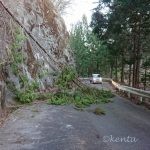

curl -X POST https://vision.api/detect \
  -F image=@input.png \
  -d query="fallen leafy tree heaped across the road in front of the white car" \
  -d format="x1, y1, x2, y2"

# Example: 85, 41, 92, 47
48, 67, 113, 108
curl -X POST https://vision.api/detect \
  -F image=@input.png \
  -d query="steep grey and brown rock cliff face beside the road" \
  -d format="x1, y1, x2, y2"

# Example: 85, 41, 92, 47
0, 0, 74, 103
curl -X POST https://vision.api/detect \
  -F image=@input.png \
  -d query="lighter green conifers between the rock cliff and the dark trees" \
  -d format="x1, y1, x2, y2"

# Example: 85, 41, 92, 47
70, 16, 108, 76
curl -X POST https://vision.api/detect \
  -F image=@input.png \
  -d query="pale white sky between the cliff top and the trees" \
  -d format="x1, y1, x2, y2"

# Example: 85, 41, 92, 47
63, 0, 98, 31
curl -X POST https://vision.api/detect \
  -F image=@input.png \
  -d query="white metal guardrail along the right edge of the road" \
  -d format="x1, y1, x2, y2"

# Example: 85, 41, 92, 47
80, 78, 150, 99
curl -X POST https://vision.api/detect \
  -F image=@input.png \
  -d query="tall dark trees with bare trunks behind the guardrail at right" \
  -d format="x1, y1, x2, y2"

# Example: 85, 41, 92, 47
91, 0, 150, 87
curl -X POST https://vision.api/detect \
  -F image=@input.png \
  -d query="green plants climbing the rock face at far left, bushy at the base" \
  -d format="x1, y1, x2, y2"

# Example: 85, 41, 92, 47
7, 28, 39, 103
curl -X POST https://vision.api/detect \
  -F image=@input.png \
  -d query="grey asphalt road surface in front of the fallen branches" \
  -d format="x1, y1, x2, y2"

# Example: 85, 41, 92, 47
0, 84, 150, 150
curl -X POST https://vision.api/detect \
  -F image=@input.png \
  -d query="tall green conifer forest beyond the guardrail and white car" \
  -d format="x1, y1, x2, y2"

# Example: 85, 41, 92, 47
70, 0, 150, 89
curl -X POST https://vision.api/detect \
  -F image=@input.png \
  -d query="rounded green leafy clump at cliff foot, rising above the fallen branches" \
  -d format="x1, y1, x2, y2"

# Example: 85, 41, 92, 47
56, 66, 77, 89
